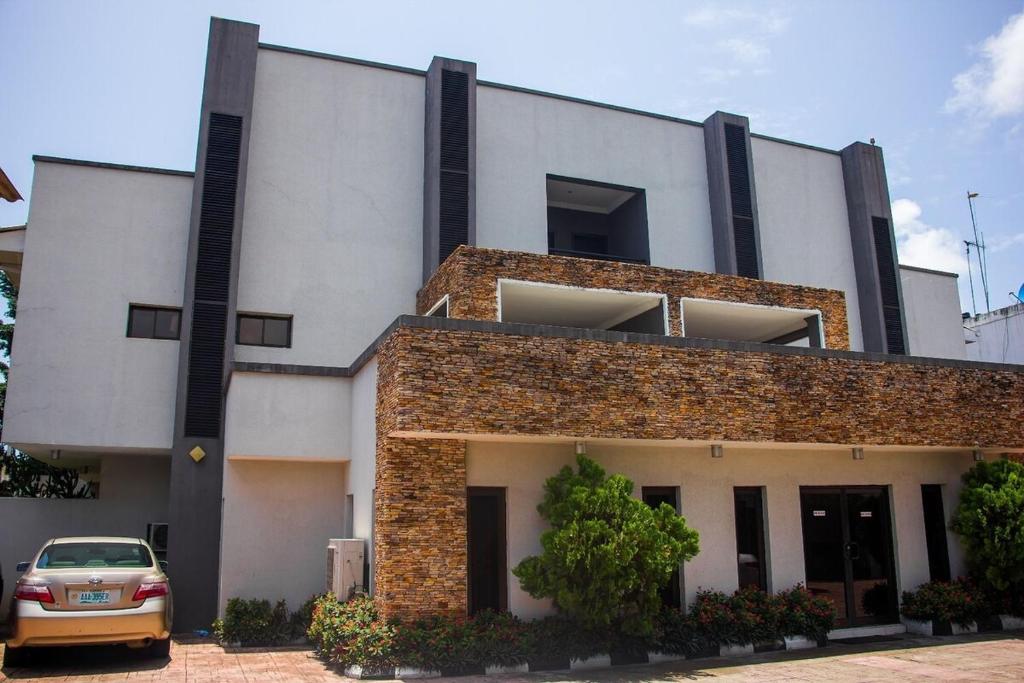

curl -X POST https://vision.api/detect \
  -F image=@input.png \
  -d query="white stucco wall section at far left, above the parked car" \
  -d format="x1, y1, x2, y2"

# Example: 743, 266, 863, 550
4, 162, 193, 452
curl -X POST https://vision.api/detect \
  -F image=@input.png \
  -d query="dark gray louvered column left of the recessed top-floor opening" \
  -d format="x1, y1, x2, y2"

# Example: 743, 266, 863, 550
423, 56, 476, 283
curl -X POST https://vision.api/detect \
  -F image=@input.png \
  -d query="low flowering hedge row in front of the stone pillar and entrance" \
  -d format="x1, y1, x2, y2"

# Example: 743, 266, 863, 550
307, 586, 836, 671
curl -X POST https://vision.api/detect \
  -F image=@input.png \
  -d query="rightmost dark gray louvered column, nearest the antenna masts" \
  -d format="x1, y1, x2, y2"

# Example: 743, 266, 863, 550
840, 142, 907, 353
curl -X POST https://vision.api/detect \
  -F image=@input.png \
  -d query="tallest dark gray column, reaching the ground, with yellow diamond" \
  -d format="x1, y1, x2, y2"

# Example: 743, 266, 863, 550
167, 18, 259, 632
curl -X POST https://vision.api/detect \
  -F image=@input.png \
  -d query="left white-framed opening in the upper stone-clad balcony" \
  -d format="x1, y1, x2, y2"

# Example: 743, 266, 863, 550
498, 280, 669, 335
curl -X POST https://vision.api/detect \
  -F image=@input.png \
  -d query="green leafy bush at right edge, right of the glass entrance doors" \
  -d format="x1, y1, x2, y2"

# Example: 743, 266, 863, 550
952, 460, 1024, 592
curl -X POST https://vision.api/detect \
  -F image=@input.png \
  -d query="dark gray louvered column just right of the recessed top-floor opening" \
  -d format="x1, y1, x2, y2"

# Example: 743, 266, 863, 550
703, 112, 764, 279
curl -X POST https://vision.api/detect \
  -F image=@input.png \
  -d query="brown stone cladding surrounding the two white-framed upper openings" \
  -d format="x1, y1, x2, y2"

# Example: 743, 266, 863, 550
416, 246, 850, 350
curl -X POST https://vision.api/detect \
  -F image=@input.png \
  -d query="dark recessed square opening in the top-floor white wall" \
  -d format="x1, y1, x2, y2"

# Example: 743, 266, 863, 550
548, 175, 650, 263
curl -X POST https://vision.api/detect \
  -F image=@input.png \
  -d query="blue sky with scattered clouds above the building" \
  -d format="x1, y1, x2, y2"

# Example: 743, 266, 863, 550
0, 0, 1024, 310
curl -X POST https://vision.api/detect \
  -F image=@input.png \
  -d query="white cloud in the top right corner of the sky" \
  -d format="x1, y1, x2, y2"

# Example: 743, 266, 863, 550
946, 12, 1024, 118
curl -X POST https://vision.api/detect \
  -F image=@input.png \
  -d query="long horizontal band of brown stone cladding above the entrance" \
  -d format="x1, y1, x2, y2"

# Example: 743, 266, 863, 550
379, 327, 1024, 450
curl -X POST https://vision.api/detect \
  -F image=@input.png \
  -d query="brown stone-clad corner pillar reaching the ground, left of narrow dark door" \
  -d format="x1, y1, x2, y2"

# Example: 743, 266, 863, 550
374, 333, 468, 620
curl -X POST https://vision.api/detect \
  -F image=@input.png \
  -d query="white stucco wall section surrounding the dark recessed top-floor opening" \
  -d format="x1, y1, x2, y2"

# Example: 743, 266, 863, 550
476, 85, 715, 271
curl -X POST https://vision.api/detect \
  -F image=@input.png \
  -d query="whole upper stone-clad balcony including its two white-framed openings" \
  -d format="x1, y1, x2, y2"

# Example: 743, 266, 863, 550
417, 246, 850, 349
